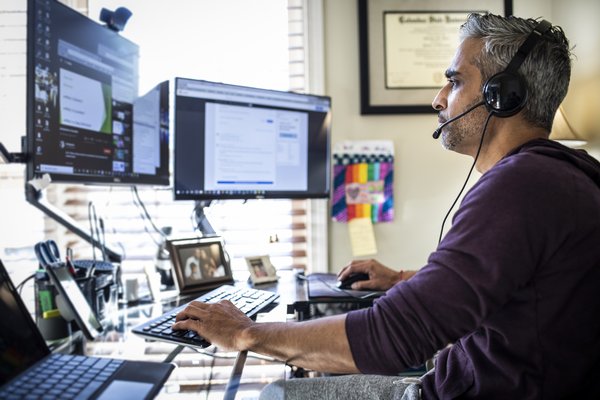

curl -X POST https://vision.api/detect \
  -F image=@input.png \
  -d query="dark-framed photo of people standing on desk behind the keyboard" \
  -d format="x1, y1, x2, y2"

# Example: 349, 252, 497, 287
167, 236, 233, 294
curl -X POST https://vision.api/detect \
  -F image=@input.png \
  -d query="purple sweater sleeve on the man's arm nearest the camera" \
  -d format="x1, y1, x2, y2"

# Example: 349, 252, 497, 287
346, 155, 548, 374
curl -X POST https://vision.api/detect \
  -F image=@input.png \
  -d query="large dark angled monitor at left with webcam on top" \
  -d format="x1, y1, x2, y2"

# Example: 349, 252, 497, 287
26, 0, 169, 185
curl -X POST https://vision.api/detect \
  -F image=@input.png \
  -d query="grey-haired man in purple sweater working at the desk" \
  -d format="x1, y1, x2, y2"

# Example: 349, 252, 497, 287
174, 14, 600, 399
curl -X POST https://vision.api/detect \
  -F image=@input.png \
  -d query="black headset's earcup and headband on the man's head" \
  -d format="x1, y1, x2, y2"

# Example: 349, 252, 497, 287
483, 20, 552, 118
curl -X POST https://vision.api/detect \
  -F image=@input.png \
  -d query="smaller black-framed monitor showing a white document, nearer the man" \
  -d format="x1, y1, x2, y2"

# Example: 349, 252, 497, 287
173, 78, 331, 200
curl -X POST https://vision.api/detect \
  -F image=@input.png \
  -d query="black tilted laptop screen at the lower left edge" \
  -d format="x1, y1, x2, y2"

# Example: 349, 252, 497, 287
0, 260, 50, 385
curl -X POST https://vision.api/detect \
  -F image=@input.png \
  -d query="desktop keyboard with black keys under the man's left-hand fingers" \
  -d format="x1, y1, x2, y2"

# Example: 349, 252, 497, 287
131, 285, 279, 347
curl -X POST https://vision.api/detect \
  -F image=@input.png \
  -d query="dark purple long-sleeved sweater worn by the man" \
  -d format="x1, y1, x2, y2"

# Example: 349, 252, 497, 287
346, 140, 600, 399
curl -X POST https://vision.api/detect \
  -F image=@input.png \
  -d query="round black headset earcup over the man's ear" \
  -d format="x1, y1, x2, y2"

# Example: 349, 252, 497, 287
483, 71, 527, 117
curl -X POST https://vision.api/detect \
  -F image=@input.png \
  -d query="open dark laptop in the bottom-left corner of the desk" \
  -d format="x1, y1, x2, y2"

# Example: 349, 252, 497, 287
0, 260, 174, 400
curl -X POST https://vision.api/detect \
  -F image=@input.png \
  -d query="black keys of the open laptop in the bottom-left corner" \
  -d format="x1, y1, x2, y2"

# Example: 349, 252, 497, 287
0, 354, 123, 400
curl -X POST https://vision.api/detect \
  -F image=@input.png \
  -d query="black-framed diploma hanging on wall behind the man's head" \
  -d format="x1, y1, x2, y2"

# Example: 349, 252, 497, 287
357, 0, 512, 115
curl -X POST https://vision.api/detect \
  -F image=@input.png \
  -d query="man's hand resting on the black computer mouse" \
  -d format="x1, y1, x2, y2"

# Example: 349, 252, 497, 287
338, 259, 414, 290
